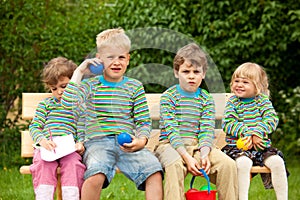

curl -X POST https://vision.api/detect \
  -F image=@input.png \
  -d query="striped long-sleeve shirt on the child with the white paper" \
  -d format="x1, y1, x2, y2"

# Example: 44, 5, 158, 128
29, 97, 83, 144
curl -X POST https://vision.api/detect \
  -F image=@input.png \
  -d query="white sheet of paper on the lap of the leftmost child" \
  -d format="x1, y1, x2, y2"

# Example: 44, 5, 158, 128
41, 135, 76, 161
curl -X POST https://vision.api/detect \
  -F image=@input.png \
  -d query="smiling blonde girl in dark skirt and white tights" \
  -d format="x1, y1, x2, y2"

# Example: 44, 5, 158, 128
222, 62, 288, 200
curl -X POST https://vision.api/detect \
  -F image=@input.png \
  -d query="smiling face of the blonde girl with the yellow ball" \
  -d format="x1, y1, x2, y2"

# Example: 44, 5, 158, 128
231, 78, 256, 98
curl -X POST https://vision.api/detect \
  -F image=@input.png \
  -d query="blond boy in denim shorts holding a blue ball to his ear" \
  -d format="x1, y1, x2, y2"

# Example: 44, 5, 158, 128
63, 28, 163, 200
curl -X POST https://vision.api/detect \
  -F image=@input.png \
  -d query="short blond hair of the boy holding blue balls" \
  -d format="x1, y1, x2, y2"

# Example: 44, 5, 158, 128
96, 28, 131, 53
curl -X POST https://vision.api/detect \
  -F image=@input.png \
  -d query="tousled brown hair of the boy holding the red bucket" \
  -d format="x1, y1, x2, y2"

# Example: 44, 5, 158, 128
173, 43, 208, 73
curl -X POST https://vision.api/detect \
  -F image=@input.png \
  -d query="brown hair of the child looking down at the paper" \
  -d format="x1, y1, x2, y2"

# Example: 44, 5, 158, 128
42, 57, 77, 89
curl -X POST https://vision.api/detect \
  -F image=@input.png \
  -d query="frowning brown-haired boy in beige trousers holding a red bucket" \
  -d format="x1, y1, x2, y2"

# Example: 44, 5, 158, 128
155, 43, 238, 200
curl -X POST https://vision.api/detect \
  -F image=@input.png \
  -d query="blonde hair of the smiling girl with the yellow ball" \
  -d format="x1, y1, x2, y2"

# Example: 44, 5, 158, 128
230, 62, 270, 96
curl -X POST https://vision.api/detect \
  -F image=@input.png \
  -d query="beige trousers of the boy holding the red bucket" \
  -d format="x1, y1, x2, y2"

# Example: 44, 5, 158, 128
155, 140, 238, 200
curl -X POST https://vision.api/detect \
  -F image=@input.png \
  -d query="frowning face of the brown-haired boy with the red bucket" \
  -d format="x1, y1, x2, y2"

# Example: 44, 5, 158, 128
174, 61, 205, 92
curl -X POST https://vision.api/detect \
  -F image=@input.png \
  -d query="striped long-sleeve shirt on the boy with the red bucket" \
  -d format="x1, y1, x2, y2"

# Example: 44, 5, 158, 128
160, 85, 215, 149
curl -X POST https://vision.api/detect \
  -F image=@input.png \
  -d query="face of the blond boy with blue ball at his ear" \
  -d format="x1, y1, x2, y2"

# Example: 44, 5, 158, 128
99, 47, 130, 82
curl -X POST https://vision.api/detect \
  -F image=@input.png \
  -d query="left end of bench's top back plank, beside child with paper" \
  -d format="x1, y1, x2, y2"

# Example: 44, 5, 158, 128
22, 93, 52, 120
